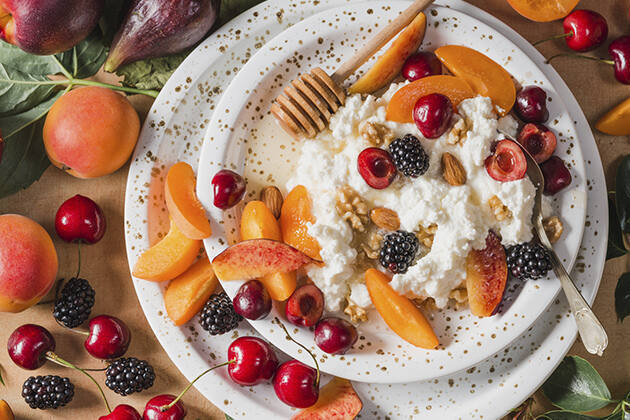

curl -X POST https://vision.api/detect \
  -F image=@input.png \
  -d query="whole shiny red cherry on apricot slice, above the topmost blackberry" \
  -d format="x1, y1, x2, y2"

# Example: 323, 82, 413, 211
413, 93, 453, 139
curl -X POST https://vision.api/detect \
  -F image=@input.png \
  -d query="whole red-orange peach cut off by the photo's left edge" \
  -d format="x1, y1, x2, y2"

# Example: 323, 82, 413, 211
0, 214, 58, 312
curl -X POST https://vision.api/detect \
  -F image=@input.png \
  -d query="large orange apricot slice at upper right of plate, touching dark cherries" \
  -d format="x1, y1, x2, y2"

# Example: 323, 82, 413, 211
435, 45, 516, 116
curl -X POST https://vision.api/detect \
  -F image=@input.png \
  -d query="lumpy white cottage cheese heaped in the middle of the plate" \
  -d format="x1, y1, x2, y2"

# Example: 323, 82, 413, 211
287, 85, 535, 311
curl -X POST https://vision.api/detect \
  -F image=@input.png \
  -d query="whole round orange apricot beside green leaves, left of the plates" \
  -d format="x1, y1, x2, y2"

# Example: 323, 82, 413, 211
44, 86, 140, 178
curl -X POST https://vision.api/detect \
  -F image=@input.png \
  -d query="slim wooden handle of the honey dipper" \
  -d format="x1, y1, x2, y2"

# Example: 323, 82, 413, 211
331, 0, 434, 85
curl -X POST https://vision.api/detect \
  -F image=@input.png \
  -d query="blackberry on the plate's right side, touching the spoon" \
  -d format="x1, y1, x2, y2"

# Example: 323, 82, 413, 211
507, 242, 552, 280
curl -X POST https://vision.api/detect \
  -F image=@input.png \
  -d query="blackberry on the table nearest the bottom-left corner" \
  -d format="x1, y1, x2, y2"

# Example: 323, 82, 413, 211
22, 375, 74, 410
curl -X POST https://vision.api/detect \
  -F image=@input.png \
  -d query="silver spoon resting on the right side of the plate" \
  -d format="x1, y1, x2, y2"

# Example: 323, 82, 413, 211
501, 132, 608, 356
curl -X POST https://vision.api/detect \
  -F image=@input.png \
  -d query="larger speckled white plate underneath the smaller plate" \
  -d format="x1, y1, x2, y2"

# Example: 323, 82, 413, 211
125, 0, 608, 419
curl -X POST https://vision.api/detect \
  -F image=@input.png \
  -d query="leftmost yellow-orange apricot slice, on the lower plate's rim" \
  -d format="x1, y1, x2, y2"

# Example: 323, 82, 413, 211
132, 220, 201, 281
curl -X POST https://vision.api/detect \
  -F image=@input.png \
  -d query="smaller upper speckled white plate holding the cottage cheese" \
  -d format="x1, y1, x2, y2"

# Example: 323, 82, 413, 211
197, 1, 586, 383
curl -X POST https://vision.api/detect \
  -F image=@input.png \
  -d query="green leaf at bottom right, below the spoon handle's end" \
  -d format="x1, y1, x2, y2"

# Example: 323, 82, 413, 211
542, 356, 613, 412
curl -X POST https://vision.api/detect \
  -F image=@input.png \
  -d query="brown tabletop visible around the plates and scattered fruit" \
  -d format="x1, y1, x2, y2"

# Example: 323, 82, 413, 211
0, 0, 630, 419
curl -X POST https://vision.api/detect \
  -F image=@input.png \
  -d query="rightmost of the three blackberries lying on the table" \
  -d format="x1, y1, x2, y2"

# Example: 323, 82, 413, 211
105, 357, 155, 397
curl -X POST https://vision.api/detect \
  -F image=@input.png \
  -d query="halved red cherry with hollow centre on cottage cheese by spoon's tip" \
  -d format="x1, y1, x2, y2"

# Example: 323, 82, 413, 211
485, 139, 527, 182
